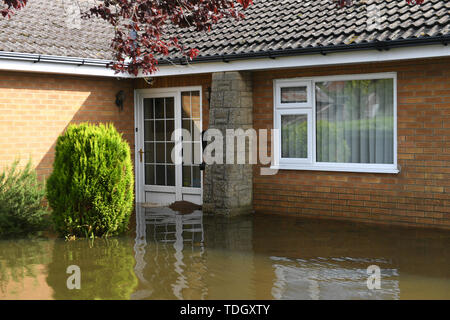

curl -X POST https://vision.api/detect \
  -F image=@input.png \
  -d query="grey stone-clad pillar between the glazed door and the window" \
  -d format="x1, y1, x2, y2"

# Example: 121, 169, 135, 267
203, 72, 253, 216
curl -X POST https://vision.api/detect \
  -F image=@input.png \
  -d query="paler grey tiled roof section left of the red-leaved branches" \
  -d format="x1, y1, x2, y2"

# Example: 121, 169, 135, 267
0, 0, 114, 60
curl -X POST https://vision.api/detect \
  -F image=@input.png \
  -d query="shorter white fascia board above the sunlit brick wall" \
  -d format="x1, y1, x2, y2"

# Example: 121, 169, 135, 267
0, 59, 134, 78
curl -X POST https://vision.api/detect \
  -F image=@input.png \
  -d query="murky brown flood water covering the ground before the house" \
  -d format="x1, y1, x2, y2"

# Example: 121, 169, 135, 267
0, 208, 450, 299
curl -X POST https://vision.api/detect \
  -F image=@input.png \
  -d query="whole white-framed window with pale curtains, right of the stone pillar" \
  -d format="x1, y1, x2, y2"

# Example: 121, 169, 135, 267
274, 74, 398, 173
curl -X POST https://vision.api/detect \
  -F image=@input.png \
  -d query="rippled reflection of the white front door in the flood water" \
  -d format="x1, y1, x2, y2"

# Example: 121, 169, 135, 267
132, 206, 206, 299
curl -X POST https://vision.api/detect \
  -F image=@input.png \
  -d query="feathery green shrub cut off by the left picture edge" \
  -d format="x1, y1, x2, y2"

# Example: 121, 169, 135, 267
0, 160, 48, 237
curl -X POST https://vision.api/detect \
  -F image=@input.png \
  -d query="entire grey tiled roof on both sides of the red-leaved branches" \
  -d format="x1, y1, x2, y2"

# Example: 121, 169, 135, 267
0, 0, 450, 61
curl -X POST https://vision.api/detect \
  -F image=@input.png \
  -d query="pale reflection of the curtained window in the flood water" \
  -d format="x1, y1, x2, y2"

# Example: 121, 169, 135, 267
271, 257, 400, 300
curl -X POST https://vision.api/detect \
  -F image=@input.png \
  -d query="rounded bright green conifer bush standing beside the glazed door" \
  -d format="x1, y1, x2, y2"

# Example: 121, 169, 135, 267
47, 123, 134, 237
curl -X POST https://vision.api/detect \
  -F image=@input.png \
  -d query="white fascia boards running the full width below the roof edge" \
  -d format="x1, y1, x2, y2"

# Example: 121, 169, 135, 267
0, 45, 450, 78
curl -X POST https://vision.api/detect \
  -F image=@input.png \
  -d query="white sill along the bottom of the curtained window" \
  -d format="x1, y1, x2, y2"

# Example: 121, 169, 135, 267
270, 164, 400, 174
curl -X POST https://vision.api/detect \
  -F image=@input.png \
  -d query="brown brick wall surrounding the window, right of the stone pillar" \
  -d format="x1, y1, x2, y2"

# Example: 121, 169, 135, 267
253, 58, 450, 228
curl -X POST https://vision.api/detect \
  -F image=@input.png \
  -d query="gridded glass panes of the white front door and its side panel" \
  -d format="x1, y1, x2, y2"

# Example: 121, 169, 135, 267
144, 91, 202, 188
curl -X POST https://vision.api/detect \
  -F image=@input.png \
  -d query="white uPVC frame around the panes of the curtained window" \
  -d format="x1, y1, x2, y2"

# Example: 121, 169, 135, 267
271, 72, 400, 174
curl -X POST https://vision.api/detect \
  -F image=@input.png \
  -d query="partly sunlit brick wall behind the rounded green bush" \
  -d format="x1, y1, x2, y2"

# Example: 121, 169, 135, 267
0, 71, 134, 176
